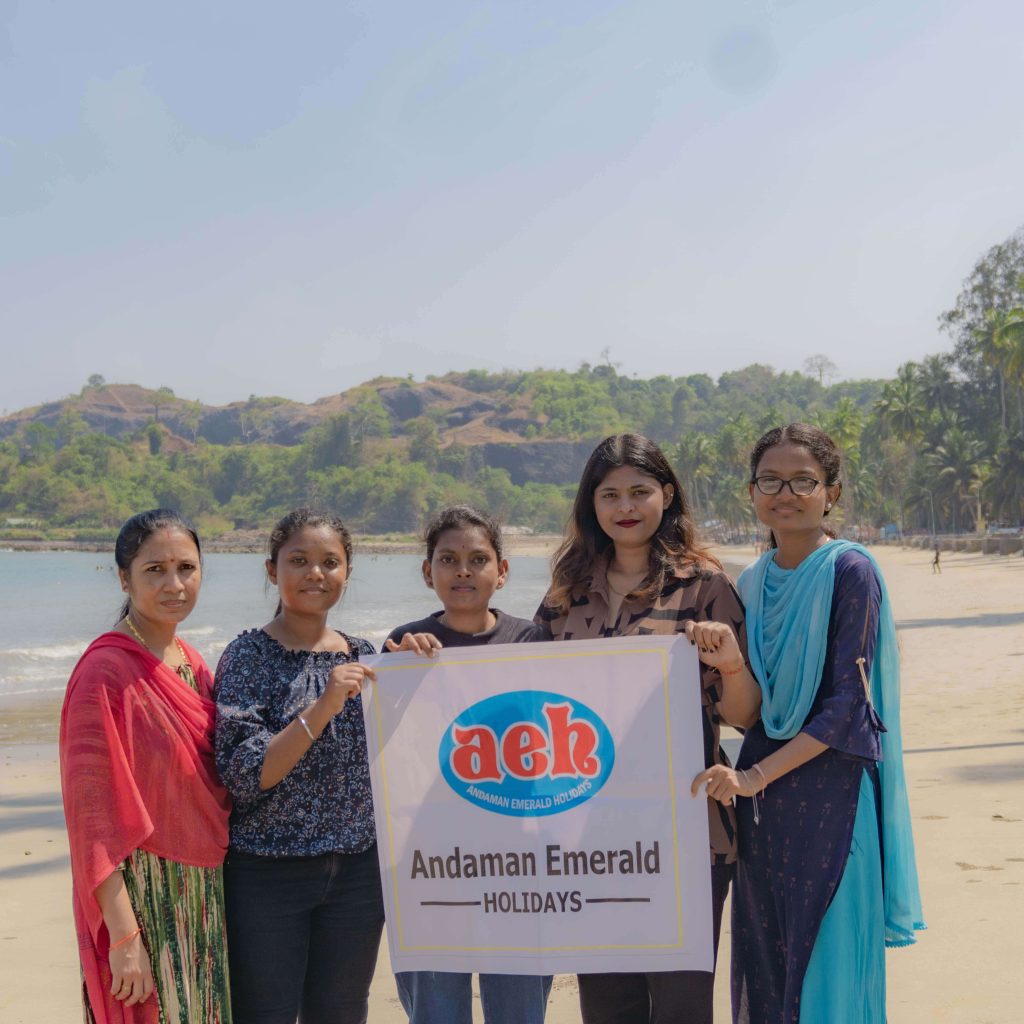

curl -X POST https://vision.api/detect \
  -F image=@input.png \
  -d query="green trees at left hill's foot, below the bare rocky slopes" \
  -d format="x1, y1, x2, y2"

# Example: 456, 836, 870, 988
0, 414, 569, 534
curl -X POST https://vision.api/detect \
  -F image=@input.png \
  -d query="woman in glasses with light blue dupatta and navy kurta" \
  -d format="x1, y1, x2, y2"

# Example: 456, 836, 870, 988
695, 423, 925, 1024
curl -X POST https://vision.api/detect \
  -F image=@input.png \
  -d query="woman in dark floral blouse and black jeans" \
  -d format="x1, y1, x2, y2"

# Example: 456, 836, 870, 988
216, 508, 425, 1024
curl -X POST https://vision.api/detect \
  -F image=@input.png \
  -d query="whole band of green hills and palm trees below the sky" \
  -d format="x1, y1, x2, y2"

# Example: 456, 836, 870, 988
0, 229, 1024, 536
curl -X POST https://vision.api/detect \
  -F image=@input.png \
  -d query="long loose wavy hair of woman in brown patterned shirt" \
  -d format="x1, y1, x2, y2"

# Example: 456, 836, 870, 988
547, 434, 722, 610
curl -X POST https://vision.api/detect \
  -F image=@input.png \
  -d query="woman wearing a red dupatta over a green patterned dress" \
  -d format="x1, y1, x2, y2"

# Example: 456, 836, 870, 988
58, 509, 231, 1024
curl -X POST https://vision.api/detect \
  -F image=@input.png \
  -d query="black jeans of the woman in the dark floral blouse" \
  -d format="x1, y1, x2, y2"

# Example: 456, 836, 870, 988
224, 847, 384, 1024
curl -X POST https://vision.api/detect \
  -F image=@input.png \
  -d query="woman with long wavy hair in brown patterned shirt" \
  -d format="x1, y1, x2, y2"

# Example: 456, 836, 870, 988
536, 434, 761, 1024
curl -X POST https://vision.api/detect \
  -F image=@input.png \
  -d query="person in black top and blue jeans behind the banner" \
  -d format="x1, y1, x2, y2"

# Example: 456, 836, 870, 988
385, 505, 552, 1024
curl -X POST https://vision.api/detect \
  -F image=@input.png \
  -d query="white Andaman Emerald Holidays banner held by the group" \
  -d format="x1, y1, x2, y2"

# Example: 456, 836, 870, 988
362, 636, 712, 974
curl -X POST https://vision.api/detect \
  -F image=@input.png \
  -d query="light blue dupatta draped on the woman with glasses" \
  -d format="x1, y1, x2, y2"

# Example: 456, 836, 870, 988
738, 541, 926, 946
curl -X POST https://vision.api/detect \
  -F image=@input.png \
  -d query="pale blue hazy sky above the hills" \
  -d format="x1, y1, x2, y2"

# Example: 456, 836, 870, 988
0, 0, 1024, 411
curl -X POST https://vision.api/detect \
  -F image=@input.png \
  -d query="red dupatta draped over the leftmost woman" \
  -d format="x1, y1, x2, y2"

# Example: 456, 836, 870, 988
59, 633, 230, 1024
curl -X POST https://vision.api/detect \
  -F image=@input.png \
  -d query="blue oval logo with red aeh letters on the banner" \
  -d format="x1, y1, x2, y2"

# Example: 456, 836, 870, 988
437, 690, 615, 817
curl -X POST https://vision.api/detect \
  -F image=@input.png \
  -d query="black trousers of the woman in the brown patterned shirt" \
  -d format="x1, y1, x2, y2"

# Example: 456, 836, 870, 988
579, 864, 736, 1024
